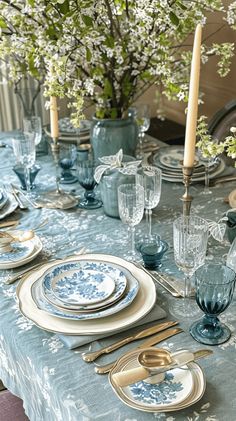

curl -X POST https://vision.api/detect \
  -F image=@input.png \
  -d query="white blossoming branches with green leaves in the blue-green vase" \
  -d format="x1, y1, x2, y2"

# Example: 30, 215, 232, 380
0, 0, 236, 126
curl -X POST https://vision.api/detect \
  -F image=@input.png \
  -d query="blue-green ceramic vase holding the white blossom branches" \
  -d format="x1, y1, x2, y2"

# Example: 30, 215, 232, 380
90, 117, 138, 161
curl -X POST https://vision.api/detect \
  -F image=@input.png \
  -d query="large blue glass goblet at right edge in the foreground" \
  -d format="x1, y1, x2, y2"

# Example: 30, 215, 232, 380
190, 263, 236, 345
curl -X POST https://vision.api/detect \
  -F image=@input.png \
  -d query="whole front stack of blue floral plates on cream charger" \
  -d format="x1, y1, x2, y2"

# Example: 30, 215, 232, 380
17, 254, 156, 335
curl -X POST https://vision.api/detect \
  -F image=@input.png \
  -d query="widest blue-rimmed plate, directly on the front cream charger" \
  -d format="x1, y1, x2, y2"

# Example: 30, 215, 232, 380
31, 262, 139, 320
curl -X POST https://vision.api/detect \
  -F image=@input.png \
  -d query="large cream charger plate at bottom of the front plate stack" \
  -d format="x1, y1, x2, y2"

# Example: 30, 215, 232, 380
17, 254, 156, 335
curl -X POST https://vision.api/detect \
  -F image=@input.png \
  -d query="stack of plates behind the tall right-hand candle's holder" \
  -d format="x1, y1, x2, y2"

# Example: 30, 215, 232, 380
153, 146, 225, 182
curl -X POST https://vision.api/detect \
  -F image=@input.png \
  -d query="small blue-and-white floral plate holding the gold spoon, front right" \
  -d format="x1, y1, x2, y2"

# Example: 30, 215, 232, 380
109, 349, 206, 412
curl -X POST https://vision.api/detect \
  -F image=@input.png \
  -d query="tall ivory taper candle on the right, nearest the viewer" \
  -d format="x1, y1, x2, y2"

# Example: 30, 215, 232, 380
183, 24, 202, 167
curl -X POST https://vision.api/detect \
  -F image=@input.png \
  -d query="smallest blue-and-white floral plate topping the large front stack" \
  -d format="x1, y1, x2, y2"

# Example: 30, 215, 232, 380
50, 265, 115, 305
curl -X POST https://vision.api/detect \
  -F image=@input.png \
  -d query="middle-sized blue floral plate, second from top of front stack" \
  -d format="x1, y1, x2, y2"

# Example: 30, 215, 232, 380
42, 260, 127, 312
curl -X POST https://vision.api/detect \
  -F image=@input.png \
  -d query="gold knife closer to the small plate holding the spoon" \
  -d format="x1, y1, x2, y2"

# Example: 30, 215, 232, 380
94, 327, 183, 374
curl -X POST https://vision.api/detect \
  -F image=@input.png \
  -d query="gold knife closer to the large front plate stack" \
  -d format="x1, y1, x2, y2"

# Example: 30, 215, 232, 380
82, 321, 179, 363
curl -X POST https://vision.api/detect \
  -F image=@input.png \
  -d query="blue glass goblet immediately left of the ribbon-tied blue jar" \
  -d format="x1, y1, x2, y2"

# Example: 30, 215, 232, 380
78, 160, 102, 209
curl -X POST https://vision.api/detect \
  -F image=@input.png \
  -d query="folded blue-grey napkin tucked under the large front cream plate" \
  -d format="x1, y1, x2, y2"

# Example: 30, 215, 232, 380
58, 304, 166, 349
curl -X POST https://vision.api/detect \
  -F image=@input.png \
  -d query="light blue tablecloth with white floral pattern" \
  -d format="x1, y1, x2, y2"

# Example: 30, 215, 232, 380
0, 134, 236, 421
